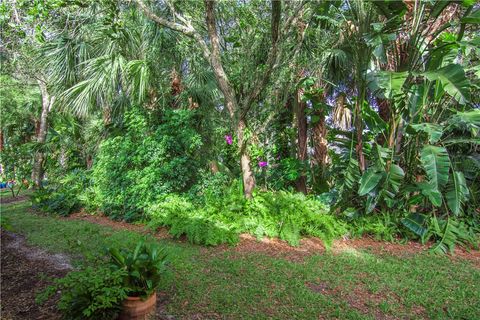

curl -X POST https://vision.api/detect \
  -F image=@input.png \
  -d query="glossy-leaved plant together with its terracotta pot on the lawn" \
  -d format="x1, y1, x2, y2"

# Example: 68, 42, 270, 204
109, 241, 167, 320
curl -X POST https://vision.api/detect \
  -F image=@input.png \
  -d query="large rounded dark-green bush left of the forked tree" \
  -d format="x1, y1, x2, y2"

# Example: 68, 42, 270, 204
93, 110, 202, 220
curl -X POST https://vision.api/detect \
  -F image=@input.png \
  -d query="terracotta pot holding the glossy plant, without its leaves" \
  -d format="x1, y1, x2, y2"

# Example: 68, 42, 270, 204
118, 292, 157, 320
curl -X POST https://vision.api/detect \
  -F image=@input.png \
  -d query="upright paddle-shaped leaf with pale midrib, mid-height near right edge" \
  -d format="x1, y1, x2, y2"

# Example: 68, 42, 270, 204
420, 145, 450, 191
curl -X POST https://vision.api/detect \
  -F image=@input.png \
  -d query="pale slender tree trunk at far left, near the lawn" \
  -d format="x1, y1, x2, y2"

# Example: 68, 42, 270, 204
32, 80, 55, 188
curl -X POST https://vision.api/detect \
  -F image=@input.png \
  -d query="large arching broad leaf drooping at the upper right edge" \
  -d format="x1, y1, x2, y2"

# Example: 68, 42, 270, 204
424, 64, 470, 104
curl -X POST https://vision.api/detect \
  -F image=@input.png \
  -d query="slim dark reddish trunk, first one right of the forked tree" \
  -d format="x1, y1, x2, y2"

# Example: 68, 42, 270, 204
295, 90, 307, 194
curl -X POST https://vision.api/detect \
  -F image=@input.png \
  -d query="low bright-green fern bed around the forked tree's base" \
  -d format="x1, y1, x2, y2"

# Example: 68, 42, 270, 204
148, 184, 346, 245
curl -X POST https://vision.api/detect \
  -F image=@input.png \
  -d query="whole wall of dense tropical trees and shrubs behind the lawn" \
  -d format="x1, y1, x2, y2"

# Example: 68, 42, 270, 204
0, 0, 480, 252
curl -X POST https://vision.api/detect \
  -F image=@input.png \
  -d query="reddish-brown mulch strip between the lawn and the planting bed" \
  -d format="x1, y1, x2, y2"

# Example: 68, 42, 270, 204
67, 211, 480, 268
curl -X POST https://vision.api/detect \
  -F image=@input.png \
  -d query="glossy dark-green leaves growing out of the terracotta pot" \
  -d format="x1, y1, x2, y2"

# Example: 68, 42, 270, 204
109, 241, 167, 298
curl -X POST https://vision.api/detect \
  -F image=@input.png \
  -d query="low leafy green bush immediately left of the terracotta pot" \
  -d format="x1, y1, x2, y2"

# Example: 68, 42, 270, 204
37, 267, 127, 320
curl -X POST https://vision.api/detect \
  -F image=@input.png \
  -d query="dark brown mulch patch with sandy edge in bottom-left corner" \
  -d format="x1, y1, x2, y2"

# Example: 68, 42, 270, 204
0, 229, 70, 320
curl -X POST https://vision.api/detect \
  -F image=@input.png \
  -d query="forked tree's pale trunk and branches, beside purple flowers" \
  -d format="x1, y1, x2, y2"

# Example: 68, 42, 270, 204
135, 0, 303, 198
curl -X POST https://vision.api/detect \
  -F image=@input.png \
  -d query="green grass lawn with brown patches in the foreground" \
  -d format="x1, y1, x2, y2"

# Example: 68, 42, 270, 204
2, 202, 480, 319
